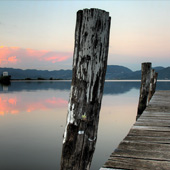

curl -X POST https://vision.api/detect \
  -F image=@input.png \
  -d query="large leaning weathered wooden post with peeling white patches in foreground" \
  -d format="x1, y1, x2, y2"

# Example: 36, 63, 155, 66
61, 9, 110, 170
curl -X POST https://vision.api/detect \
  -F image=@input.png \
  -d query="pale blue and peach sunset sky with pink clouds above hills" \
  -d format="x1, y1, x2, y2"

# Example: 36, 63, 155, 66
0, 0, 170, 70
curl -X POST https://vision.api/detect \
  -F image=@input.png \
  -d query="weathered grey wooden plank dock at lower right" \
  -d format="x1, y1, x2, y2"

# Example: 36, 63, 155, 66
100, 91, 170, 170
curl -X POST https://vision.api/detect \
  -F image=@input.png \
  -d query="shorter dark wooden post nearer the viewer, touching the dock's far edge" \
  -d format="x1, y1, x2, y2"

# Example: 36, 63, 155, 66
137, 63, 151, 119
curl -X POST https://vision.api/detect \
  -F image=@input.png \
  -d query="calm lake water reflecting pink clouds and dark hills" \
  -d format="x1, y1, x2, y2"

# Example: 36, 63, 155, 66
0, 81, 170, 170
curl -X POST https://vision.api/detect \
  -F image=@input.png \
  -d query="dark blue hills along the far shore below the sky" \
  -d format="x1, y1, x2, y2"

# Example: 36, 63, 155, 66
0, 65, 170, 80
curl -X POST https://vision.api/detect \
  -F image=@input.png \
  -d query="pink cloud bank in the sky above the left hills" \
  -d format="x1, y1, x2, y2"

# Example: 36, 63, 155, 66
0, 46, 72, 66
